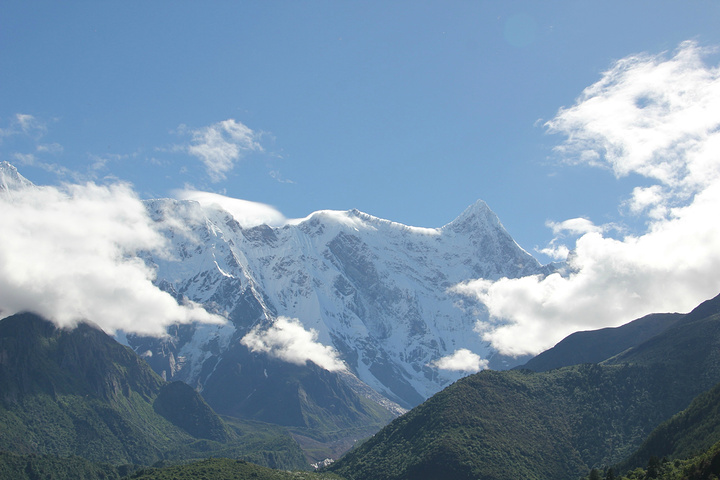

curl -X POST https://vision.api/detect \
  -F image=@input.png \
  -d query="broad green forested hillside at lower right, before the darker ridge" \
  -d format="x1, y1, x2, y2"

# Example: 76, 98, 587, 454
330, 292, 720, 479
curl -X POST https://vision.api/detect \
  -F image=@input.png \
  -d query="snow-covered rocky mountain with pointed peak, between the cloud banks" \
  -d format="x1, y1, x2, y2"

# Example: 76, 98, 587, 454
128, 199, 544, 407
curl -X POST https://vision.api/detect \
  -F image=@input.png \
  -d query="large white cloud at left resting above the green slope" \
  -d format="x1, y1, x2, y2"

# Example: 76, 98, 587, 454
0, 179, 224, 335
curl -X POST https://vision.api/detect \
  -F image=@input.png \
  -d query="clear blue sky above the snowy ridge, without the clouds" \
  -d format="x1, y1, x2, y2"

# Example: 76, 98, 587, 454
0, 0, 720, 261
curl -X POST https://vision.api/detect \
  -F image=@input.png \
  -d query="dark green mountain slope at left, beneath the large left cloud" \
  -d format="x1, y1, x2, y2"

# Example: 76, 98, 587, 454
0, 313, 306, 467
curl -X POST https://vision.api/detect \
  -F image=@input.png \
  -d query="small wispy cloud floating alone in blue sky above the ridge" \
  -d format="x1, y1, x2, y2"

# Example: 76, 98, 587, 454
179, 118, 263, 182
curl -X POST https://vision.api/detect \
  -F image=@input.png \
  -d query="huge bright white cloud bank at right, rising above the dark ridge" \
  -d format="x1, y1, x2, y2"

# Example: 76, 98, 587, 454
455, 42, 720, 355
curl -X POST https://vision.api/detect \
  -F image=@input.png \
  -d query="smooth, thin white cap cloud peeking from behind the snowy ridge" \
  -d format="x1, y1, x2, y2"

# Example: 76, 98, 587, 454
174, 190, 286, 228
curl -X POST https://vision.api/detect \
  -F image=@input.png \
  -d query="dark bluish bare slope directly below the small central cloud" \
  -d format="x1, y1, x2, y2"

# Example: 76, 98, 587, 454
198, 338, 397, 463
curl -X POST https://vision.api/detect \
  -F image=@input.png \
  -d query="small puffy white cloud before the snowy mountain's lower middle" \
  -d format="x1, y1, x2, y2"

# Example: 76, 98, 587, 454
240, 317, 345, 371
